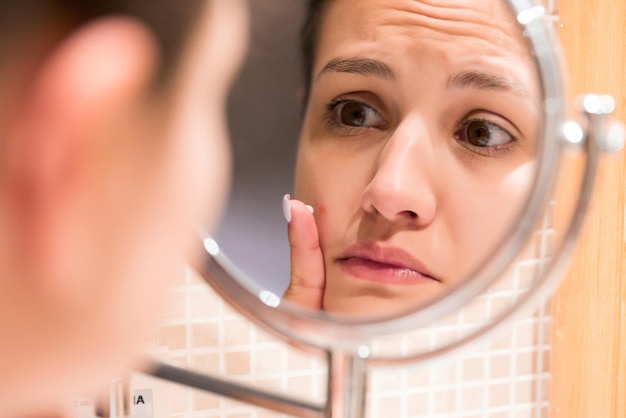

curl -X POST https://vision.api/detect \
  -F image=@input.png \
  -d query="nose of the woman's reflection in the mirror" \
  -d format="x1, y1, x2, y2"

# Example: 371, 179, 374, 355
361, 119, 437, 227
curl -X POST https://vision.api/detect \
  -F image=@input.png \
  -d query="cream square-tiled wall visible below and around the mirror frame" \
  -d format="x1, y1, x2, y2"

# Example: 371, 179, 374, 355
150, 211, 553, 418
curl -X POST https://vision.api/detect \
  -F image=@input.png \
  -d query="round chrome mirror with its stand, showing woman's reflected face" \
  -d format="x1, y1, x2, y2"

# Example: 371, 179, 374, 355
145, 0, 623, 416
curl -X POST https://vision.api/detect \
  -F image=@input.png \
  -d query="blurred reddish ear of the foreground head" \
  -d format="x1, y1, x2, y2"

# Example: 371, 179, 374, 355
2, 17, 157, 274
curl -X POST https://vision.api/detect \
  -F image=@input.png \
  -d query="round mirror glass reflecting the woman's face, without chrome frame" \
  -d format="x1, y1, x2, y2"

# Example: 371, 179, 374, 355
216, 0, 543, 317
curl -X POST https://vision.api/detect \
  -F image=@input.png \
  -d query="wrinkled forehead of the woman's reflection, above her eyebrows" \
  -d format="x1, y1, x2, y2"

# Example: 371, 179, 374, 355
313, 0, 538, 93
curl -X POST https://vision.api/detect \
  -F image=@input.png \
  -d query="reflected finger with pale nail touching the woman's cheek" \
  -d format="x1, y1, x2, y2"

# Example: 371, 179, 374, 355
283, 195, 326, 310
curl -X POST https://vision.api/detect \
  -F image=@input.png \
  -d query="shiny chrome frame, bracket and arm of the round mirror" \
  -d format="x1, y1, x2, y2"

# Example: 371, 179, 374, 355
144, 0, 624, 418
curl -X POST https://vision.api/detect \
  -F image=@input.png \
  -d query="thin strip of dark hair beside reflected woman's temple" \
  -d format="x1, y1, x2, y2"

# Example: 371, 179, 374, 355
300, 0, 331, 105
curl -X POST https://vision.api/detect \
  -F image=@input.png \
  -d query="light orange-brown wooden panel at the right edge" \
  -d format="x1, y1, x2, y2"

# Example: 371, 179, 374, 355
550, 0, 626, 418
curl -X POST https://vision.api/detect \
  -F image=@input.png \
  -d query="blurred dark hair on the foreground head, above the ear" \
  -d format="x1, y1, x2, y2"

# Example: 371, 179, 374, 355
0, 0, 205, 85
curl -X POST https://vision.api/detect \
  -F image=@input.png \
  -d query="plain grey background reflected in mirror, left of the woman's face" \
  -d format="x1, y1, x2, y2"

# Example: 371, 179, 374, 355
216, 0, 305, 295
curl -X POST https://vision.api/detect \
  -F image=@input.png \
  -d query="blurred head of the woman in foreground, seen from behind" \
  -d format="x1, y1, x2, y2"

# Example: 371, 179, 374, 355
0, 0, 247, 416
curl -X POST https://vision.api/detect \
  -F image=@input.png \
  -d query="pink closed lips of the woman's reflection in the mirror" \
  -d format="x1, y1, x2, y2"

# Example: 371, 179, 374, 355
337, 244, 441, 284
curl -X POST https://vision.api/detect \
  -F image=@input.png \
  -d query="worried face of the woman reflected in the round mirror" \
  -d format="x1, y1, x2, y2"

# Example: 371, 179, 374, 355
295, 0, 541, 314
